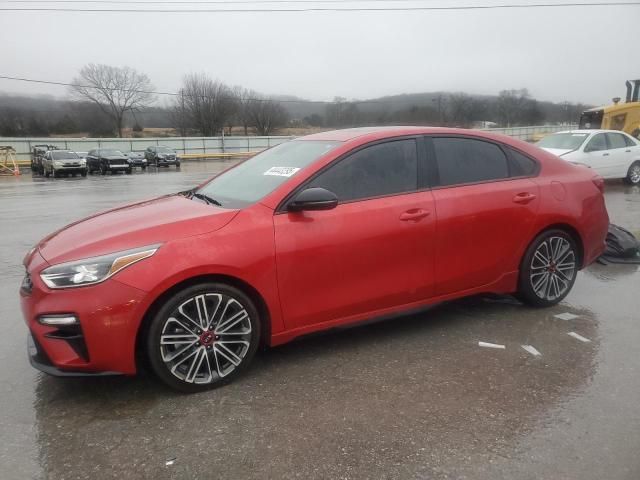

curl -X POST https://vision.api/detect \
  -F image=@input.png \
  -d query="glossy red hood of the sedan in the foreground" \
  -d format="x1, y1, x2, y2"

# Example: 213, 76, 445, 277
38, 195, 238, 264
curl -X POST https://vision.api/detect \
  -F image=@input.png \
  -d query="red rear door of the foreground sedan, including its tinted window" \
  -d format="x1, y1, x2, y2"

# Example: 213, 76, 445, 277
427, 136, 539, 295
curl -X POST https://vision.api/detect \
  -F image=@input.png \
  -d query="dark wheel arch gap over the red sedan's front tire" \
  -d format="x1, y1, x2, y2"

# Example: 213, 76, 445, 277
135, 274, 271, 365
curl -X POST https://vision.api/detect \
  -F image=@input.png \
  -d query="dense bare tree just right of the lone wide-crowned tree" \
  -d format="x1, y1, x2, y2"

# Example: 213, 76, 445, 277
181, 73, 238, 137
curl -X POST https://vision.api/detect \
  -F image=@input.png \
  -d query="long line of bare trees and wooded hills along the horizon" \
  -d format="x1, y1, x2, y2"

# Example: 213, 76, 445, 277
0, 64, 587, 136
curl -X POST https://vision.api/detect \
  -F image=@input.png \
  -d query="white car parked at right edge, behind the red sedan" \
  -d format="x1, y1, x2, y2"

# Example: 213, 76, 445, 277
538, 130, 640, 185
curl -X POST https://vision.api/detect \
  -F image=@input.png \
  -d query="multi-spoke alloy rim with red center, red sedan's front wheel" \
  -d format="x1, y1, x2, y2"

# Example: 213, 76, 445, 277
160, 293, 252, 384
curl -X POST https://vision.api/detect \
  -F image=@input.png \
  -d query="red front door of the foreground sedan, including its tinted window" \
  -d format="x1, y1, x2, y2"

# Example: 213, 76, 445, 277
274, 138, 435, 328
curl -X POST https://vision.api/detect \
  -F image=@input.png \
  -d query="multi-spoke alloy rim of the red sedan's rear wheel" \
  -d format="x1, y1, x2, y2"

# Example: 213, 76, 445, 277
529, 237, 576, 301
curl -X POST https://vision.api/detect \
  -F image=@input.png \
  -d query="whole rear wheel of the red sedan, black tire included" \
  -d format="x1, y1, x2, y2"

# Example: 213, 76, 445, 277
517, 229, 580, 307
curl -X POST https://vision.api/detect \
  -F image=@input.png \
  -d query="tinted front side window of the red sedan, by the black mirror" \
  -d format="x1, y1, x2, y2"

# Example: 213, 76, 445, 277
308, 139, 418, 202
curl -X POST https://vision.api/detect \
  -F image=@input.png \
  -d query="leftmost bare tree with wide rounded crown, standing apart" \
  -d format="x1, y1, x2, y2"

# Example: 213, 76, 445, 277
71, 63, 154, 137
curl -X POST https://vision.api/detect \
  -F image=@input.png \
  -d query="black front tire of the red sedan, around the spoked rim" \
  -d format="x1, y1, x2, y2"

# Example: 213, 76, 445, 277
144, 282, 261, 393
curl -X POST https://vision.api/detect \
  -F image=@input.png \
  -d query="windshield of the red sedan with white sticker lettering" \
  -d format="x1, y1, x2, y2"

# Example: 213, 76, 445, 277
198, 140, 340, 208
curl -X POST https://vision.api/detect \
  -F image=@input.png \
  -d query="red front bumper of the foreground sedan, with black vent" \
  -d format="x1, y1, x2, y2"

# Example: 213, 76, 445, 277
20, 253, 148, 376
